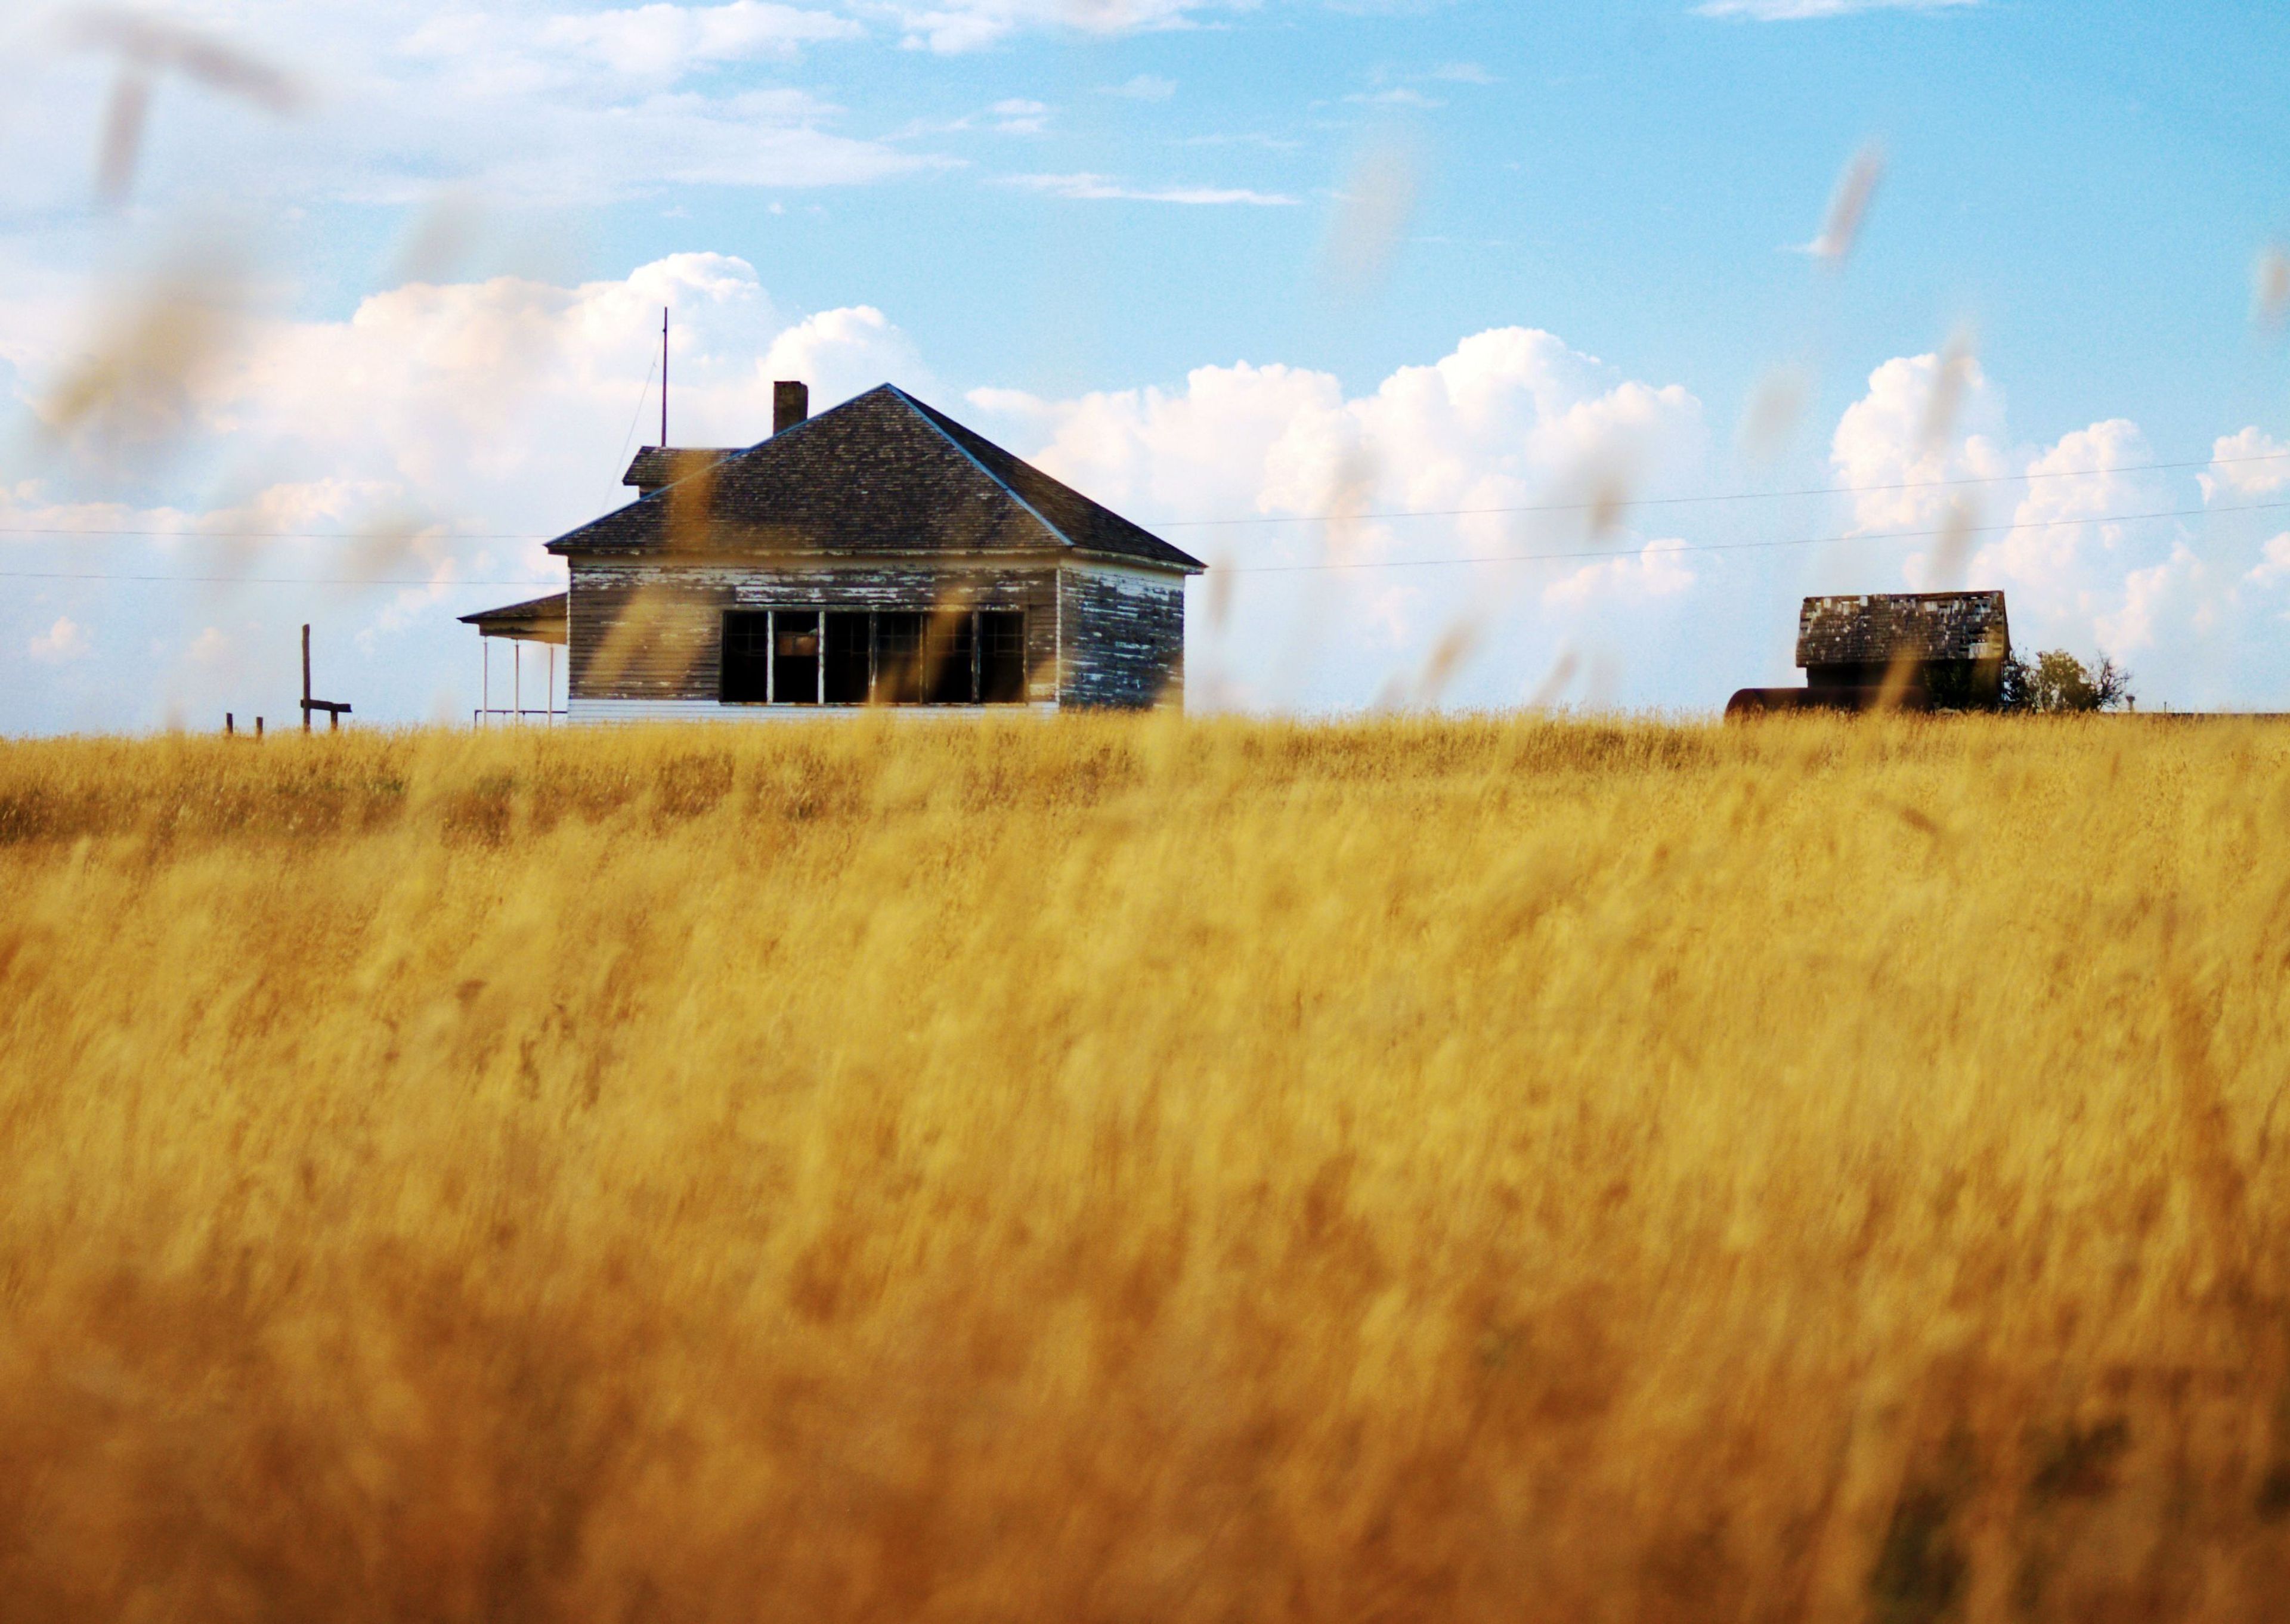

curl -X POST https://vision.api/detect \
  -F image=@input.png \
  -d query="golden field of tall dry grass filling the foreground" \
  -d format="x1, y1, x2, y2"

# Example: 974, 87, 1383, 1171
0, 719, 2290, 1624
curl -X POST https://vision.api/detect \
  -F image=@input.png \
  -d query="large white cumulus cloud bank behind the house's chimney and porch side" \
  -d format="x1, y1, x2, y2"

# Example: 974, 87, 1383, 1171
0, 254, 934, 729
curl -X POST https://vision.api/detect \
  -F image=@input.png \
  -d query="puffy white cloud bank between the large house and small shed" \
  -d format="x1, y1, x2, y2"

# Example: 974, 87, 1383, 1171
971, 327, 1706, 705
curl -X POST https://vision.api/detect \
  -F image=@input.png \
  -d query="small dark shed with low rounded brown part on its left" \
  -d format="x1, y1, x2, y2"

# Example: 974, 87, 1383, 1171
1725, 591, 2011, 717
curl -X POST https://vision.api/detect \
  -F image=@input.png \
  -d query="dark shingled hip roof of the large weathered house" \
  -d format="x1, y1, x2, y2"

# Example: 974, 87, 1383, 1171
550, 385, 1207, 575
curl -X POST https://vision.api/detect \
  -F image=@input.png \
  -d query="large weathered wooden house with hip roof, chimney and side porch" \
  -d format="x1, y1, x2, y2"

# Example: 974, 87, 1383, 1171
463, 383, 1205, 721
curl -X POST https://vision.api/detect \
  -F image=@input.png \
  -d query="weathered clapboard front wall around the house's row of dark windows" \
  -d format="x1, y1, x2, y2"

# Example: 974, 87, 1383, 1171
568, 559, 1058, 703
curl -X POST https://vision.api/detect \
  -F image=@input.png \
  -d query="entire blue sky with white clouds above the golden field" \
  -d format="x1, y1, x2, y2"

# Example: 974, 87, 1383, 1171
0, 0, 2290, 733
